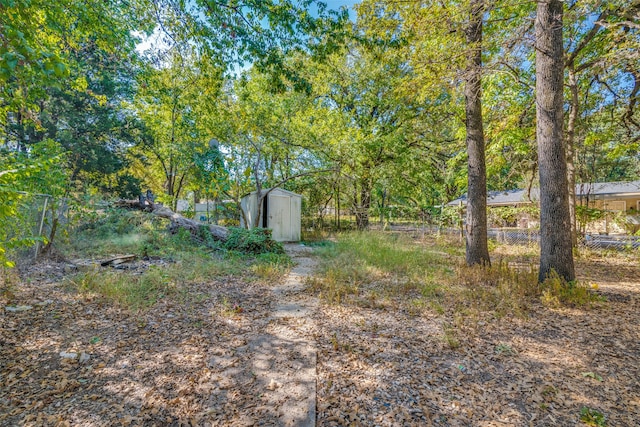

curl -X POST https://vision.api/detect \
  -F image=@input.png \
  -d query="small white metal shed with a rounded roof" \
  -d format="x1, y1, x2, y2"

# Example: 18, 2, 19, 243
240, 188, 302, 242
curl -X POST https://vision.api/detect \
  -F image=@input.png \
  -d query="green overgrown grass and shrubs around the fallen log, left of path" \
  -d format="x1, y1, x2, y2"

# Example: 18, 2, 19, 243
61, 209, 291, 310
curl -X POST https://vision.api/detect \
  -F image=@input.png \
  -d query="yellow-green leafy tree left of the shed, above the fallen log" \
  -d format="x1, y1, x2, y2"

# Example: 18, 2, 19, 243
132, 47, 222, 209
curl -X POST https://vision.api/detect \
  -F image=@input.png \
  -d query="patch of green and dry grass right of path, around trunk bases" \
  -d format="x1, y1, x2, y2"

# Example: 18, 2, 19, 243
312, 233, 603, 318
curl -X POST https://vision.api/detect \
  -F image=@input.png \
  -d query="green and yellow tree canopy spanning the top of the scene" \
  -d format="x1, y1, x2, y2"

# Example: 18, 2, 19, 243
0, 0, 640, 280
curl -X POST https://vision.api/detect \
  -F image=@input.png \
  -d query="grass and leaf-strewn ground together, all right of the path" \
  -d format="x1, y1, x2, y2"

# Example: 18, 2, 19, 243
314, 233, 640, 426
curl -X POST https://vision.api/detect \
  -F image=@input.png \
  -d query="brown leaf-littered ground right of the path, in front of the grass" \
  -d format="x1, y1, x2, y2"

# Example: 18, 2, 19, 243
316, 242, 640, 427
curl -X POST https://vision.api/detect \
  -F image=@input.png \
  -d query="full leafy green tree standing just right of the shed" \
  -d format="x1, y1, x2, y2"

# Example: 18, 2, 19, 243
311, 36, 427, 229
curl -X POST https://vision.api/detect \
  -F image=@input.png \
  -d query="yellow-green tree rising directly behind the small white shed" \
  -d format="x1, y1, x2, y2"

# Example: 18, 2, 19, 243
209, 68, 327, 228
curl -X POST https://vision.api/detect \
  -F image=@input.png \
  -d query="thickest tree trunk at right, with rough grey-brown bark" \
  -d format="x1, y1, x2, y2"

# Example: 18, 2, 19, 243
535, 0, 575, 281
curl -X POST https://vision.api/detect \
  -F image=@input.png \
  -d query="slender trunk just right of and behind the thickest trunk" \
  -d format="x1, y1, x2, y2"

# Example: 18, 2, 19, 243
566, 64, 580, 247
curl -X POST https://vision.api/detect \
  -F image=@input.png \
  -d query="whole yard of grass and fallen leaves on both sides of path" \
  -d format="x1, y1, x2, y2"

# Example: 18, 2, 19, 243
0, 220, 640, 426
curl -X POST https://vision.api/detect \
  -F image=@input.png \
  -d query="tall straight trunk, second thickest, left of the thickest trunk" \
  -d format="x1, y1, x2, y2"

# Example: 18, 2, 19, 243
464, 0, 490, 265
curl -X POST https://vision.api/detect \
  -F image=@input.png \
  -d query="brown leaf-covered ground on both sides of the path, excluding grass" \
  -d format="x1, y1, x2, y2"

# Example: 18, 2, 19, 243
0, 246, 640, 426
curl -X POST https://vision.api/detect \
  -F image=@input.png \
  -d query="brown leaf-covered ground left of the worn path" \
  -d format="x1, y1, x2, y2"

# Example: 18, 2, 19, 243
0, 264, 294, 426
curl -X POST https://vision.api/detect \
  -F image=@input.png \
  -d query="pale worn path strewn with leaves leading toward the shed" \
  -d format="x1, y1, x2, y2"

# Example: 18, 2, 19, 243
249, 244, 317, 426
